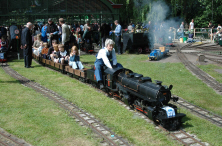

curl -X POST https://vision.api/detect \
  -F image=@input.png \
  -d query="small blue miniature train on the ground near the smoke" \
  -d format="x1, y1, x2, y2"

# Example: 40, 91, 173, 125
148, 47, 169, 60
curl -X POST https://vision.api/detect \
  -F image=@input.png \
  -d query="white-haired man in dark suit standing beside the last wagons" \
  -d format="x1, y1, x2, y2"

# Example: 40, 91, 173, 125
21, 22, 32, 68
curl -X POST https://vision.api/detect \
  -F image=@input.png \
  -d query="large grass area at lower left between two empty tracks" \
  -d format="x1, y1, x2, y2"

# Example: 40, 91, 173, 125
0, 68, 98, 146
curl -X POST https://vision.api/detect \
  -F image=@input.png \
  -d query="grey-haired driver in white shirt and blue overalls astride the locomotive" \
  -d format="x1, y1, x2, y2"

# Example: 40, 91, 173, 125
95, 39, 123, 89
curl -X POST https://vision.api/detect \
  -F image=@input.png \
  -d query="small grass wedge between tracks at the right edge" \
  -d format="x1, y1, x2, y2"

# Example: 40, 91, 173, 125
198, 64, 222, 83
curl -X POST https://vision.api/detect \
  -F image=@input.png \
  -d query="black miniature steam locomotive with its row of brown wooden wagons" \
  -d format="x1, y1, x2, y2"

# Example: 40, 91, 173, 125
33, 54, 186, 130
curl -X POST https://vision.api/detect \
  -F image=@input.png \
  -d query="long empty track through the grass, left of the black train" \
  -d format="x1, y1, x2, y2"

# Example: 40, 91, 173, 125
0, 64, 130, 146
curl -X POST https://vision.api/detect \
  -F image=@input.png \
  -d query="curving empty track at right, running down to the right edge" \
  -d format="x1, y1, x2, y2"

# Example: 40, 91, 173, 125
177, 46, 222, 95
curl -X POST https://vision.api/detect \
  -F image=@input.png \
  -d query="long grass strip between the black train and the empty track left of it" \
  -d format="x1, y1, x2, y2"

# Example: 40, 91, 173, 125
7, 60, 178, 146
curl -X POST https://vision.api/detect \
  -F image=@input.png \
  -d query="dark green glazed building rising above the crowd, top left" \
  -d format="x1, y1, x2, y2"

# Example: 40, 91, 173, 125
0, 0, 119, 25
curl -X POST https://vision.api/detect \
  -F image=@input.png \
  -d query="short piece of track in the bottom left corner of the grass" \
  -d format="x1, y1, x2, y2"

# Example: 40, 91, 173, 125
0, 128, 31, 146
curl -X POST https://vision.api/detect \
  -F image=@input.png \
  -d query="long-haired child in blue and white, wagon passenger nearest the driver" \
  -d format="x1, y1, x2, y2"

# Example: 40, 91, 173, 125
69, 46, 84, 69
